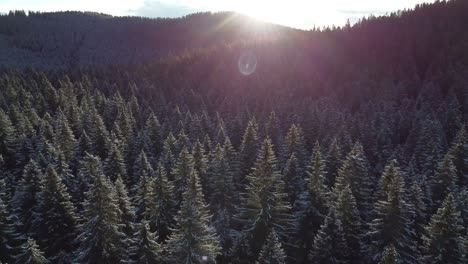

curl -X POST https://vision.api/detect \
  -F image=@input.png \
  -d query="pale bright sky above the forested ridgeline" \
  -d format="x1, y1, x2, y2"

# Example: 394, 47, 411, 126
0, 0, 433, 29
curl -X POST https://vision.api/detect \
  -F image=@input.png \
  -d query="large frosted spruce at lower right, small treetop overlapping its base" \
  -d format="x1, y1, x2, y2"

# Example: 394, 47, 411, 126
366, 162, 419, 263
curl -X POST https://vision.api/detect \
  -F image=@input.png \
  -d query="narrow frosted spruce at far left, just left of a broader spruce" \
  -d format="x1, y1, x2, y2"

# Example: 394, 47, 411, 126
12, 160, 43, 233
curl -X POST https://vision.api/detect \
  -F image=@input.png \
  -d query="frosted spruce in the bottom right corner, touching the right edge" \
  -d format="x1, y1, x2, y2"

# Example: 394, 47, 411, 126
421, 194, 467, 264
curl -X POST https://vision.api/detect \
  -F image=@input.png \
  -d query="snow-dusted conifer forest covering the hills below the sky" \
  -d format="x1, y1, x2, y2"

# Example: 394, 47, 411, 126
0, 0, 468, 264
